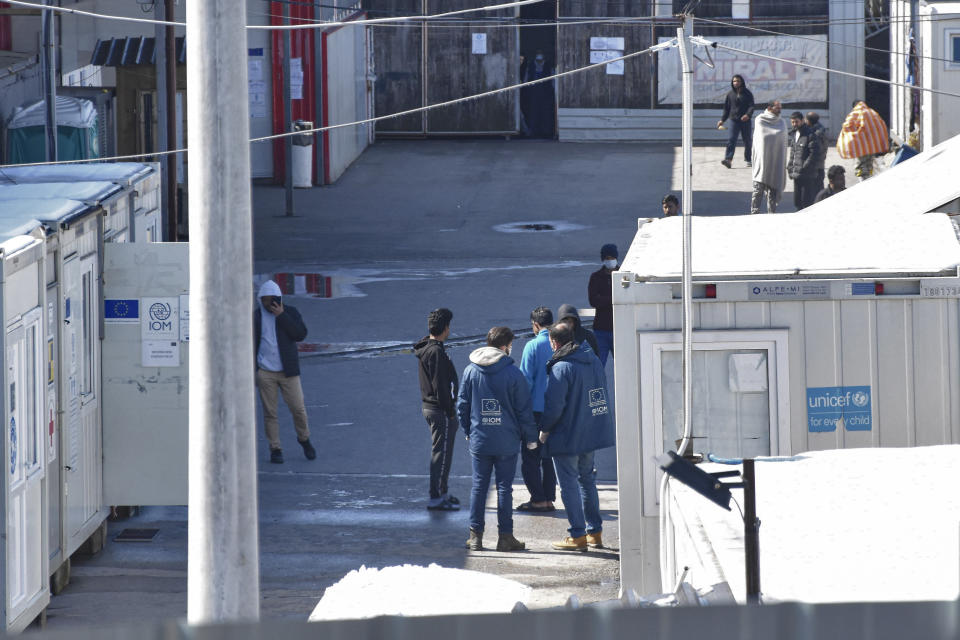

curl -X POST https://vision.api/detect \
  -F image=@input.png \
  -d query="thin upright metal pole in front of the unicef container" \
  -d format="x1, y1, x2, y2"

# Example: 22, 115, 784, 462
677, 15, 693, 455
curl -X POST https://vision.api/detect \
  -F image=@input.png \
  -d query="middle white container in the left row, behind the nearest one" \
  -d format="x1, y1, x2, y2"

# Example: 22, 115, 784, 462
31, 199, 109, 590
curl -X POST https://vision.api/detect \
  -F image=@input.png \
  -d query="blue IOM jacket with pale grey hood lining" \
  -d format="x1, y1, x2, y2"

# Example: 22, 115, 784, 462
457, 347, 538, 456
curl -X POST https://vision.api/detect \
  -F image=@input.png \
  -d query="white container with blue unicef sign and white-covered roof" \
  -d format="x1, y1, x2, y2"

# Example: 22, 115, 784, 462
612, 209, 960, 593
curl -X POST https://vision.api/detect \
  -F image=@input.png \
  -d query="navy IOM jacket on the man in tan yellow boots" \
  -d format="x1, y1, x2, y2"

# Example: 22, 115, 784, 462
540, 343, 616, 456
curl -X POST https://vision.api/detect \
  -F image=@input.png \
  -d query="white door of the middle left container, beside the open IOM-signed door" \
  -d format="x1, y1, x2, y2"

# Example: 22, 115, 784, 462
61, 254, 103, 555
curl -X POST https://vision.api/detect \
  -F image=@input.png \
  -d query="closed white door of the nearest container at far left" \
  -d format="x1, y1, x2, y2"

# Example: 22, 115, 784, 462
5, 307, 47, 625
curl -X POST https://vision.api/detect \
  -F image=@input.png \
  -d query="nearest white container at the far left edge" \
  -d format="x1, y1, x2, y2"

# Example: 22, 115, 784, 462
0, 234, 50, 631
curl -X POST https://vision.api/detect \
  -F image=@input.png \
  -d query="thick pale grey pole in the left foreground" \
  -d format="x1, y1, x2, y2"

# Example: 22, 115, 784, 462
186, 0, 260, 624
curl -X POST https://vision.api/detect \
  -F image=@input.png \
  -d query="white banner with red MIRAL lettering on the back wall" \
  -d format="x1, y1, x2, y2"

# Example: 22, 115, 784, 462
657, 35, 827, 104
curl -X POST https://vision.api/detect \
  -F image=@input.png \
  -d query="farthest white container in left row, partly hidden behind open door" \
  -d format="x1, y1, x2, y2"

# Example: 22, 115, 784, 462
0, 162, 161, 242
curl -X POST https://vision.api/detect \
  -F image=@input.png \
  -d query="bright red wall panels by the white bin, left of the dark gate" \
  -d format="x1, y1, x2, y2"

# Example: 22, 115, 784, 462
270, 2, 318, 183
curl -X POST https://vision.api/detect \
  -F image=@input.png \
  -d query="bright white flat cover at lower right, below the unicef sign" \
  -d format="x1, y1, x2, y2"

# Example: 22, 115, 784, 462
670, 445, 960, 602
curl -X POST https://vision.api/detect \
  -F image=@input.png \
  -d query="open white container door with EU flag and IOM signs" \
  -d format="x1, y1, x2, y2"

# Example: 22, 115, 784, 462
102, 242, 190, 506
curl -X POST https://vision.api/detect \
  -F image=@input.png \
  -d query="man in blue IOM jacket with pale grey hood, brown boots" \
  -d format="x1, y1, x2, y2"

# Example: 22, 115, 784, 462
457, 327, 537, 551
